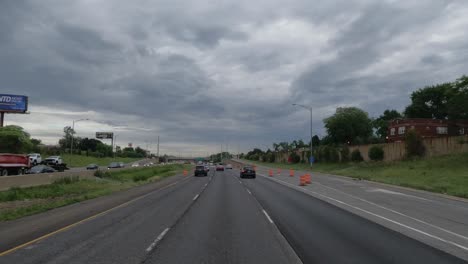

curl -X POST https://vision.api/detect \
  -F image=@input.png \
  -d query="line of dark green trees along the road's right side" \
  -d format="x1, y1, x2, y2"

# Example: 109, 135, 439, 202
242, 73, 468, 162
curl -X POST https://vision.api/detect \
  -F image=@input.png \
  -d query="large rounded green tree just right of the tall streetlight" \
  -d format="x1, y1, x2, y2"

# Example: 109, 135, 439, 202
324, 107, 372, 144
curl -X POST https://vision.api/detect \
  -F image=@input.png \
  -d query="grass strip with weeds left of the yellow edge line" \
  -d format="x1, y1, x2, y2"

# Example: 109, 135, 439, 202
0, 165, 190, 221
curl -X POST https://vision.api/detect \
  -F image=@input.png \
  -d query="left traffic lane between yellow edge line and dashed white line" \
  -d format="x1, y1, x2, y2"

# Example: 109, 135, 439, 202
0, 173, 210, 263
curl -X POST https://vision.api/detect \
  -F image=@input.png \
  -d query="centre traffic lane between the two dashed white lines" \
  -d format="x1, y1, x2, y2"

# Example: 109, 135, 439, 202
145, 170, 300, 264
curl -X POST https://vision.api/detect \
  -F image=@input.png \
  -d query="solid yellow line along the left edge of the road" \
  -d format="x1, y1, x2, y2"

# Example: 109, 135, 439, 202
0, 178, 189, 257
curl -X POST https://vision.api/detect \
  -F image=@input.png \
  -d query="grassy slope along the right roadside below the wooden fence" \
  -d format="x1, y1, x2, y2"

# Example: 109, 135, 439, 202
247, 153, 468, 198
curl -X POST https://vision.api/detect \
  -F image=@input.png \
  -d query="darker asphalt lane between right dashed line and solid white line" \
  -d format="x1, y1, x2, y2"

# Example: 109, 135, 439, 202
242, 174, 465, 263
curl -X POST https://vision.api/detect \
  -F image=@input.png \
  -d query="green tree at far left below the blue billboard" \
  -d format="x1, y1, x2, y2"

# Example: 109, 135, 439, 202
0, 125, 33, 153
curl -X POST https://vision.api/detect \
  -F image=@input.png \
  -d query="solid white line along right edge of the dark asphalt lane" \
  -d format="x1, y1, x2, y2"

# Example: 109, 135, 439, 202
259, 174, 468, 251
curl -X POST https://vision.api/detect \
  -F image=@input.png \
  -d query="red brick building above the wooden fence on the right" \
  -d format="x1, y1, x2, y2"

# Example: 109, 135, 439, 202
387, 118, 468, 142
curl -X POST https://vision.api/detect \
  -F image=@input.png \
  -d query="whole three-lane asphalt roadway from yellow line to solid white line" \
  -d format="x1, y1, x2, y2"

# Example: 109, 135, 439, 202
0, 170, 465, 263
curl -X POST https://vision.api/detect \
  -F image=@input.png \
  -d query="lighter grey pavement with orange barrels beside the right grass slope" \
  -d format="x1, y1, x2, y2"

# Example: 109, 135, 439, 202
247, 162, 468, 244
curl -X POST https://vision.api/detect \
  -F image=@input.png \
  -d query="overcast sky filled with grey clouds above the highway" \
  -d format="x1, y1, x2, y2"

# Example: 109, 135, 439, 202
0, 0, 468, 155
